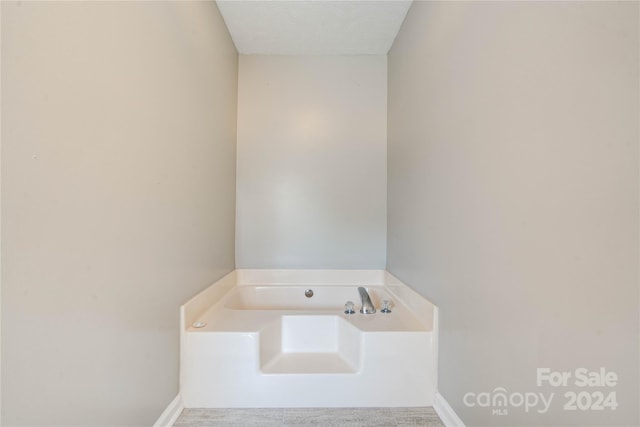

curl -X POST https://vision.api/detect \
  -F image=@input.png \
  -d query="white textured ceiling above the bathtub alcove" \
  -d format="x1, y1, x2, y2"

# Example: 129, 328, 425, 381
217, 0, 411, 55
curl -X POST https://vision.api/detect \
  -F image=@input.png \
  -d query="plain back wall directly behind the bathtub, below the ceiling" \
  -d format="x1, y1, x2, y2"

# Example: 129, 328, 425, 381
236, 55, 387, 268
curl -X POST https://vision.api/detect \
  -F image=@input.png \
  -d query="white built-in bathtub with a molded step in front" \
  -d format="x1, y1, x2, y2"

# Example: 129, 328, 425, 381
180, 270, 437, 408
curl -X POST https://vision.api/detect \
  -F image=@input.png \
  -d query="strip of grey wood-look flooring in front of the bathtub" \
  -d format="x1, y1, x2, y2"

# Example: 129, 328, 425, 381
173, 407, 444, 427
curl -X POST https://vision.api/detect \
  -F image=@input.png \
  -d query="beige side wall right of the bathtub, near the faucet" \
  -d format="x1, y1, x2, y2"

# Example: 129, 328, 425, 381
388, 2, 639, 426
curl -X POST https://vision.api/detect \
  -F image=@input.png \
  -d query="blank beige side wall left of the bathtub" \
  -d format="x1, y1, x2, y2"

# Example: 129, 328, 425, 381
2, 2, 237, 426
